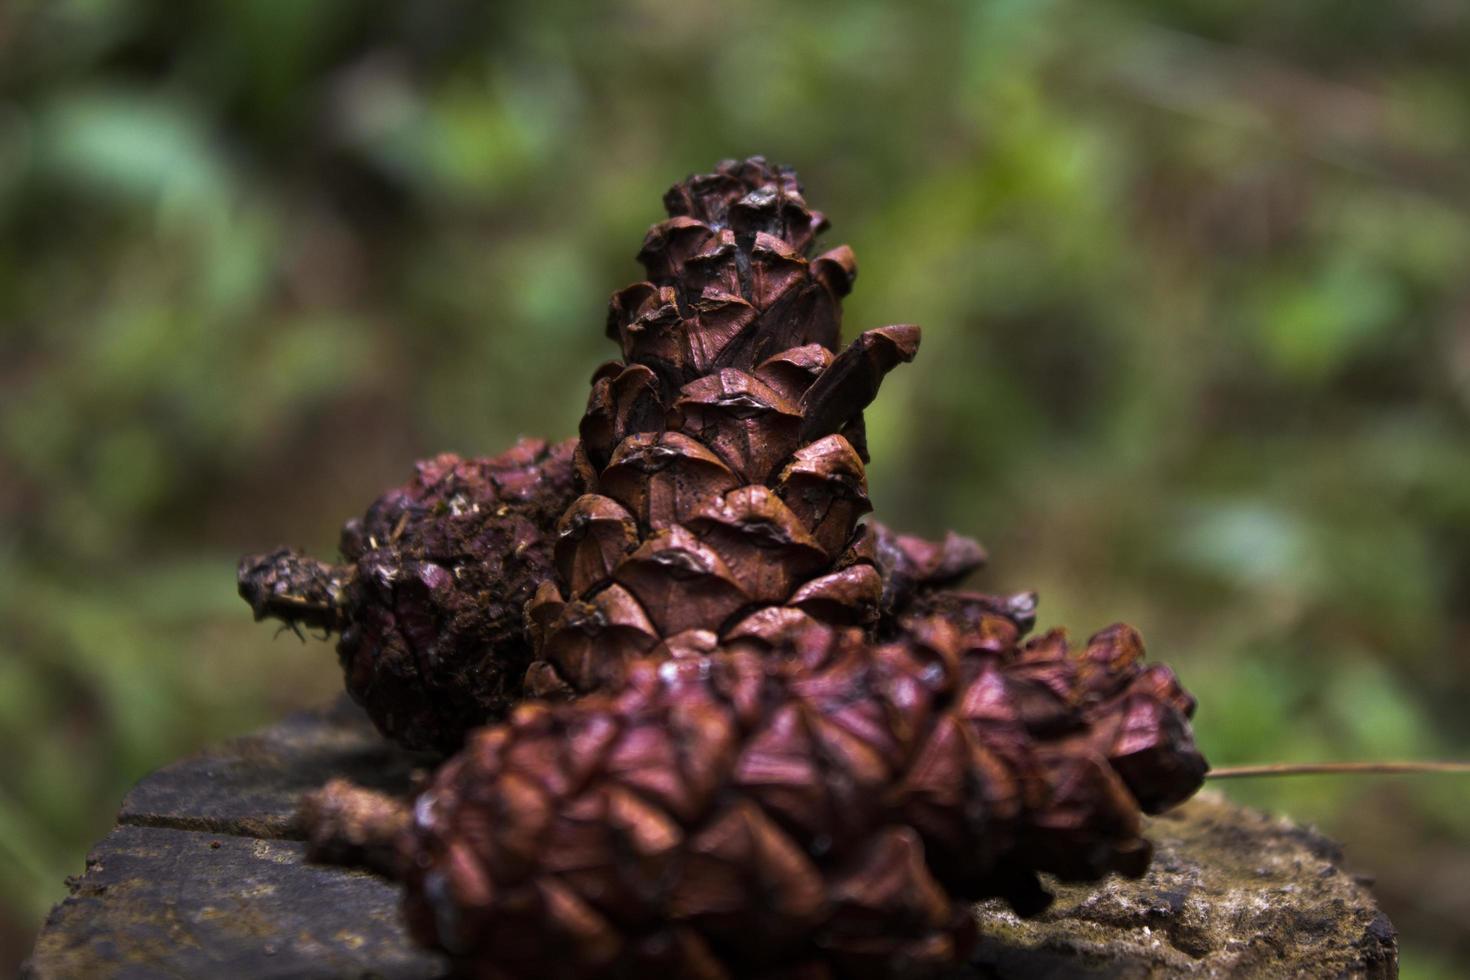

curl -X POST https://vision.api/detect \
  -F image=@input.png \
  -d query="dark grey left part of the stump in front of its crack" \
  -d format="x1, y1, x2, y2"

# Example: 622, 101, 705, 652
31, 826, 442, 980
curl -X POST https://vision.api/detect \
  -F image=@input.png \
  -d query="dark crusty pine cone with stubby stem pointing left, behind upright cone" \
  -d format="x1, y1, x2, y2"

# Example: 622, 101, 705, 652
240, 439, 576, 751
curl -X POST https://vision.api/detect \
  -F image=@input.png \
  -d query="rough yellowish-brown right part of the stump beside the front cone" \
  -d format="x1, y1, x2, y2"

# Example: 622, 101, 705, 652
975, 792, 1398, 979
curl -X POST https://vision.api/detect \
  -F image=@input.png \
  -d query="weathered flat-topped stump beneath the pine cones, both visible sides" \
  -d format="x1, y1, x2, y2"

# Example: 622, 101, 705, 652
25, 704, 1398, 980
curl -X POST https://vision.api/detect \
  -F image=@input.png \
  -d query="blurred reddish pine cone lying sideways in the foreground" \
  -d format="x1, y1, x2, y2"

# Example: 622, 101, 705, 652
403, 597, 1205, 977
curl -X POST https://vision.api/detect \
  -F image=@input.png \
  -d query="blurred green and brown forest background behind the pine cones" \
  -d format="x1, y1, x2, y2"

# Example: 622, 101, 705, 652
0, 0, 1470, 977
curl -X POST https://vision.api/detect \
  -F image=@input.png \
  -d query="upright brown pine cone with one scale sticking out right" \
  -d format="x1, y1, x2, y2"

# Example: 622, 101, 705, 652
528, 157, 917, 698
